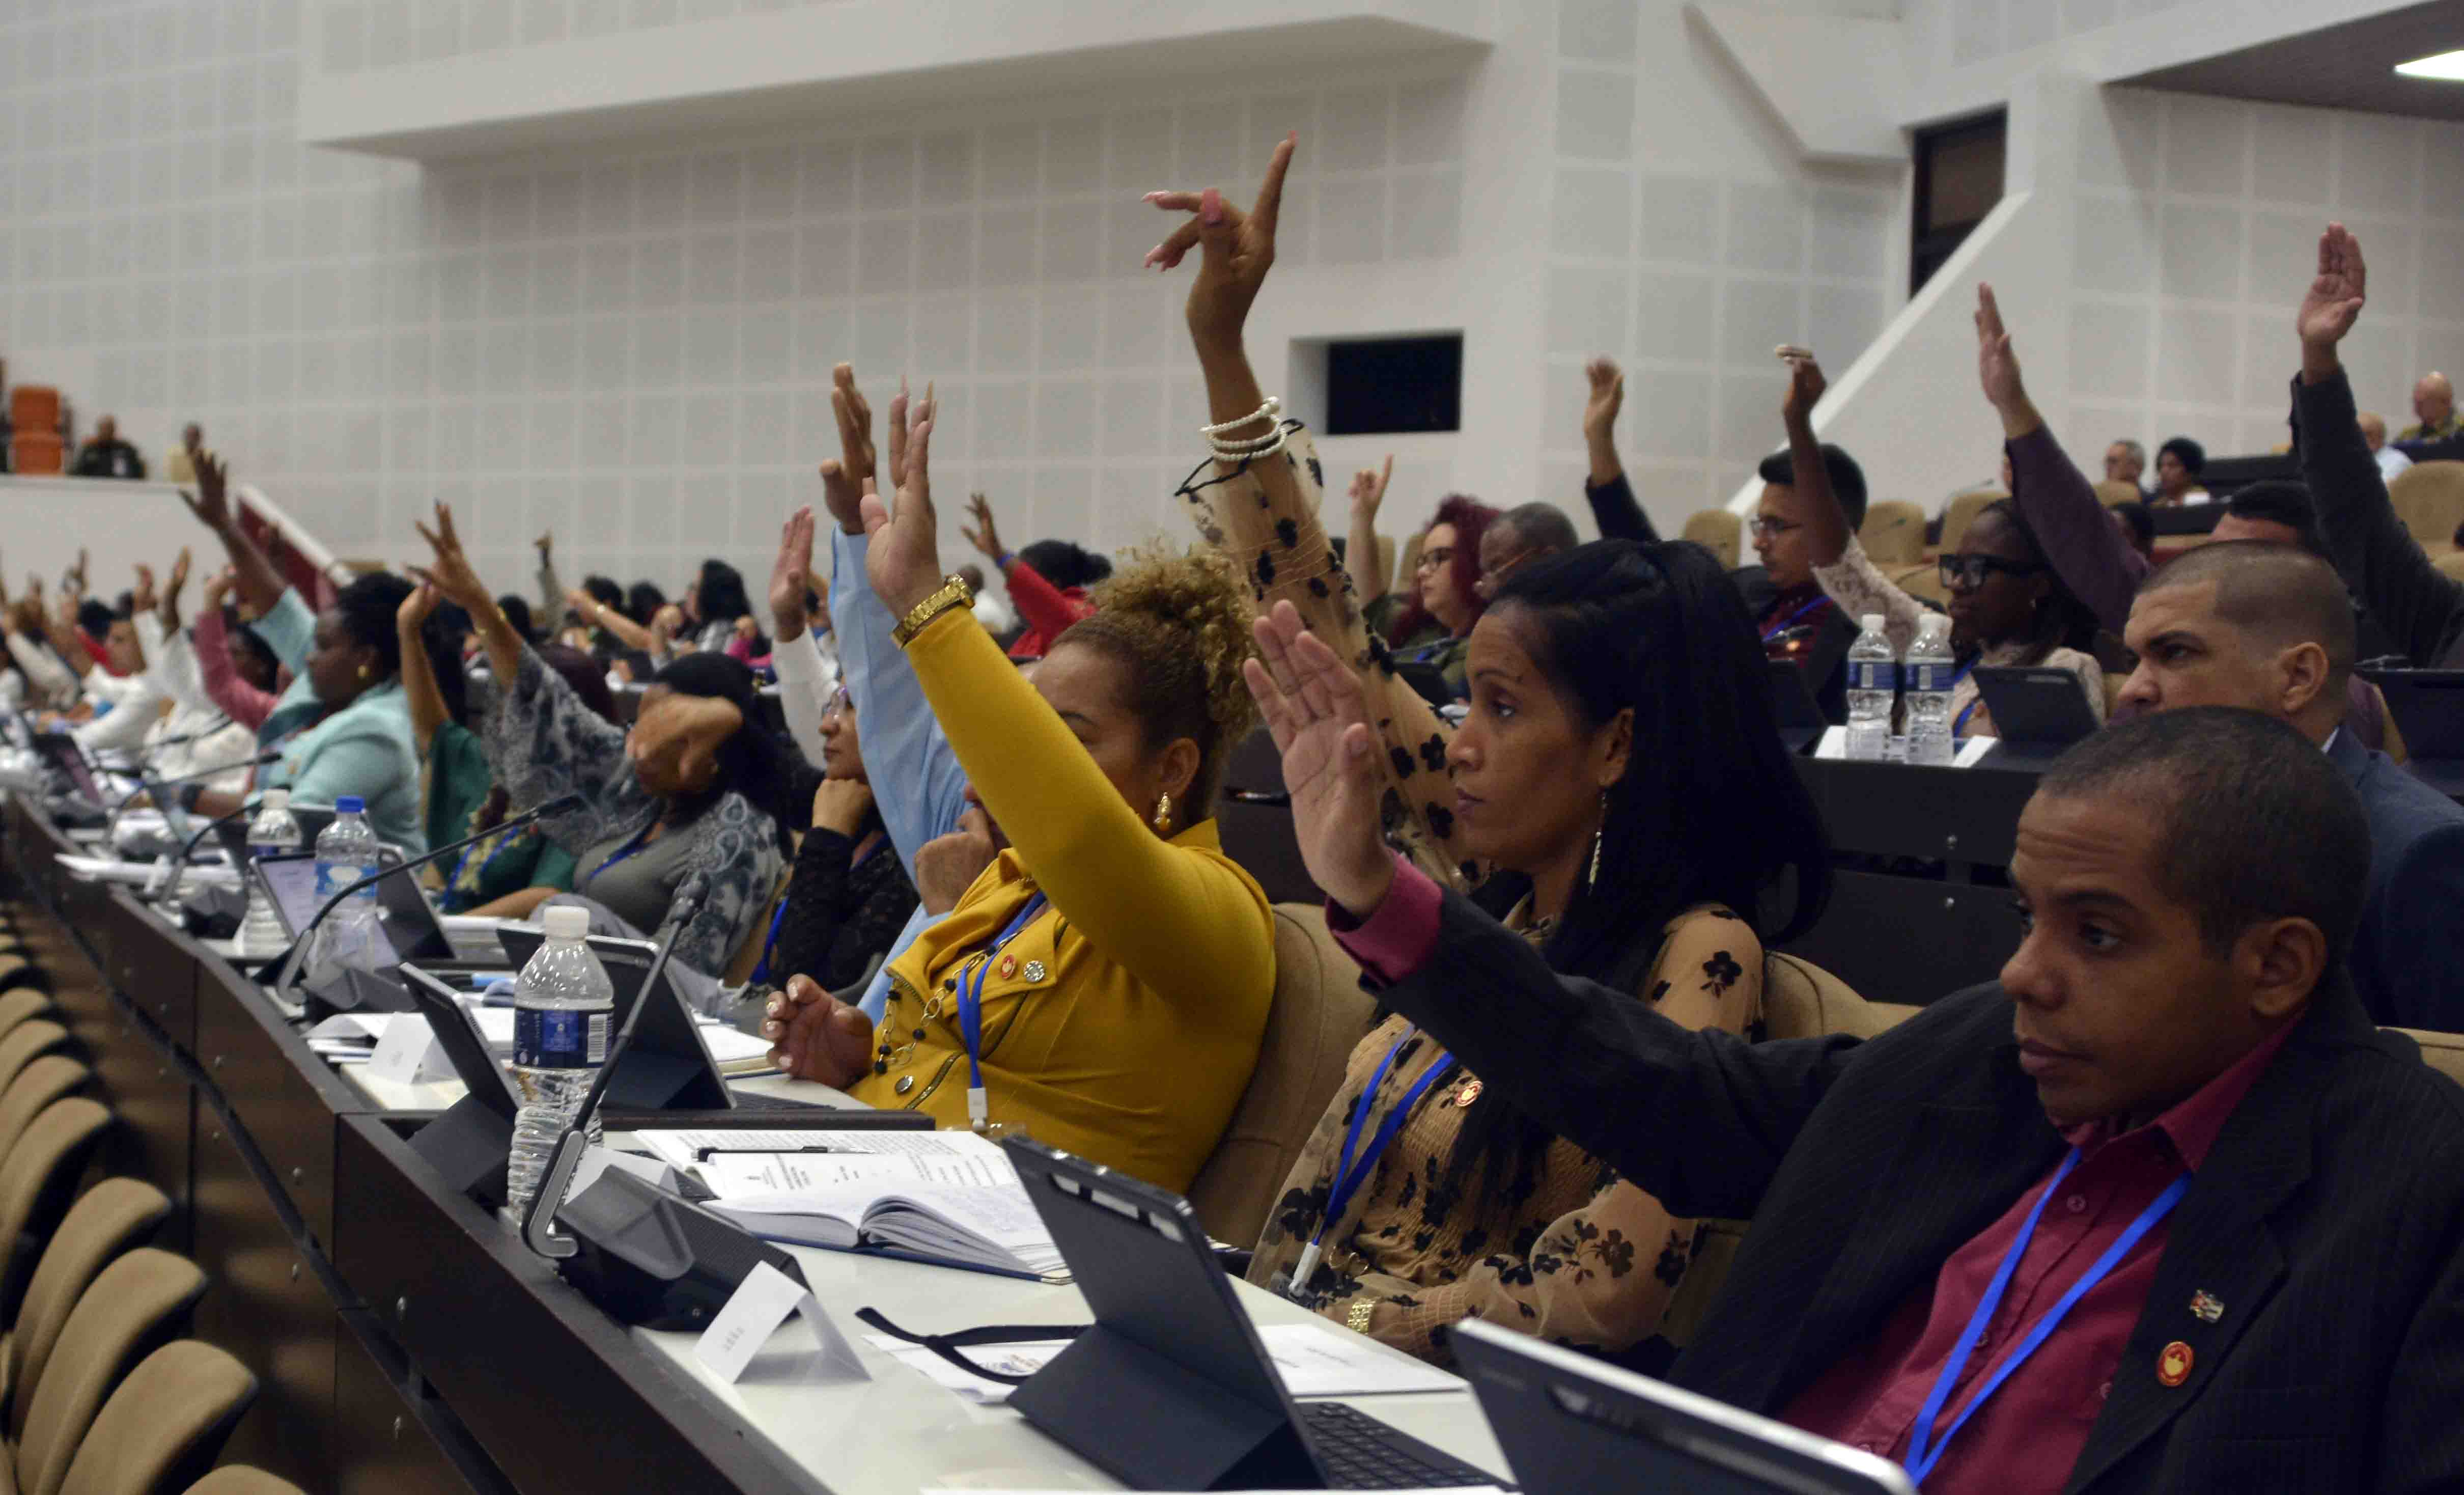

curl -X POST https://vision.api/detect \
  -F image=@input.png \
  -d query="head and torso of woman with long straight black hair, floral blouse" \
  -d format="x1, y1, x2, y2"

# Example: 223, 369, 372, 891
1249, 539, 1828, 1360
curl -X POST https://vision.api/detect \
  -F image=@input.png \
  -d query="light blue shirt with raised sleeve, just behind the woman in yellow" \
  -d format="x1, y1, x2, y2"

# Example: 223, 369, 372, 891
828, 524, 966, 1022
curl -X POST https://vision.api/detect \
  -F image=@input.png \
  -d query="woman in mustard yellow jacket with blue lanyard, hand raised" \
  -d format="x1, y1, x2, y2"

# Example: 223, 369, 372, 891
764, 379, 1274, 1189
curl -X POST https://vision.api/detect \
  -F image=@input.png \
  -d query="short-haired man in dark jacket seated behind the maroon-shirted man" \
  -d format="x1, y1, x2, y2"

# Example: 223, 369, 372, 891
2121, 539, 2464, 1032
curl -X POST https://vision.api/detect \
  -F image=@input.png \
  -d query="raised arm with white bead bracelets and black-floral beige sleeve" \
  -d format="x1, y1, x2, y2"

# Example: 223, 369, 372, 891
1148, 138, 1471, 884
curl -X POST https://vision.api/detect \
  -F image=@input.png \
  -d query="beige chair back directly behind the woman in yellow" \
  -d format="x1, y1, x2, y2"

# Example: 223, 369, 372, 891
1190, 904, 1375, 1246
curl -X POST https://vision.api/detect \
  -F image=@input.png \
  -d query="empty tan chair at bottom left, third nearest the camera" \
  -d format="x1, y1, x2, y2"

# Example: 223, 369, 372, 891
10, 1246, 205, 1495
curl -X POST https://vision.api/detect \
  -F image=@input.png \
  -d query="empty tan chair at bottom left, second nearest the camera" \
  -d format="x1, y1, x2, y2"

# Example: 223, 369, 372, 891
59, 1340, 256, 1495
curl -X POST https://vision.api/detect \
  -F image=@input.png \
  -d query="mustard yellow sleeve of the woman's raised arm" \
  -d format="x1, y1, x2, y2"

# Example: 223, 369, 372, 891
907, 611, 1274, 1003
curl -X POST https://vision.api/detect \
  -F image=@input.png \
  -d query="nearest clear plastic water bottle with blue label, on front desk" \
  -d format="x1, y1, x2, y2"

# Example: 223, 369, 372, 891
505, 904, 616, 1224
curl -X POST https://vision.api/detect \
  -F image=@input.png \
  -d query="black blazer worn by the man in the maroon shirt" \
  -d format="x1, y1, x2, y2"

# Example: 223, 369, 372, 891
1382, 894, 2464, 1495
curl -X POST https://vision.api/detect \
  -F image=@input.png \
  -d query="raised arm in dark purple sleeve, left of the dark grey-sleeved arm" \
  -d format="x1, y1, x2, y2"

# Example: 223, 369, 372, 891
1976, 286, 2148, 630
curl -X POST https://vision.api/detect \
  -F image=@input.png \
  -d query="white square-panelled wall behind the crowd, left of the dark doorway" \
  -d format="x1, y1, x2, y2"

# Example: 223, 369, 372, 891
0, 0, 1900, 598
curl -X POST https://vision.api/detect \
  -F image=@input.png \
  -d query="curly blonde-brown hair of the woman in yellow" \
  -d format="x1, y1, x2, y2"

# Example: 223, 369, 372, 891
1052, 542, 1256, 820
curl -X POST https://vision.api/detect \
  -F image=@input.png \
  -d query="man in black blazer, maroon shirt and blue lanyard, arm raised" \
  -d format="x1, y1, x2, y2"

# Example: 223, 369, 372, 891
1252, 608, 2464, 1495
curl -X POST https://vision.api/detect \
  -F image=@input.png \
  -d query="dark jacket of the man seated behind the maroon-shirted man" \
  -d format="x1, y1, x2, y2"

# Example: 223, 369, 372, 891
2326, 732, 2464, 1032
